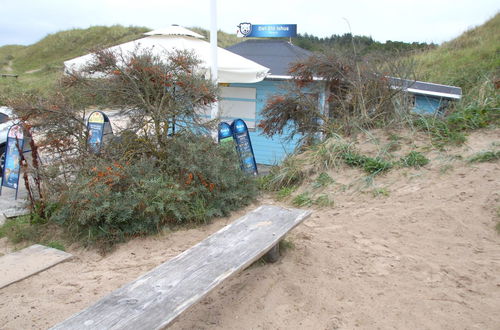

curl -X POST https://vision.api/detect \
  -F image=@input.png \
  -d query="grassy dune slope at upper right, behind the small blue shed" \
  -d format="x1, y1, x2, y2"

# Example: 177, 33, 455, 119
415, 13, 500, 94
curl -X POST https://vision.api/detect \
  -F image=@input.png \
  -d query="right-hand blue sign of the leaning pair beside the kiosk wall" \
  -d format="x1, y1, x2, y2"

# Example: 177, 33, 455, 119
231, 119, 257, 175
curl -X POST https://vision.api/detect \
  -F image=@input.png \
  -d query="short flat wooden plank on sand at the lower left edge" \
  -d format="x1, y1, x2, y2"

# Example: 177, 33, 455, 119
0, 244, 73, 289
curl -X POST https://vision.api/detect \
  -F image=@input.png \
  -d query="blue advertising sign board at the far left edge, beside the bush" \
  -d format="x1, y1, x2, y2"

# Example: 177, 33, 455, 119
2, 125, 24, 198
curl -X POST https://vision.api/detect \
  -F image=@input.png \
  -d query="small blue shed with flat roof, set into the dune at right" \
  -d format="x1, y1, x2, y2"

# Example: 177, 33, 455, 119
389, 77, 462, 115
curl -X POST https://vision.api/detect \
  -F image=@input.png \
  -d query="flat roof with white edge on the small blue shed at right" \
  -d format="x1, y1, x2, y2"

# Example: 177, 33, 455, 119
389, 77, 462, 99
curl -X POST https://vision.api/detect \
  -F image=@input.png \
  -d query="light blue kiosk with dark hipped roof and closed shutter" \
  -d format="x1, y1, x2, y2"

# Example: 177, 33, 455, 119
219, 39, 325, 165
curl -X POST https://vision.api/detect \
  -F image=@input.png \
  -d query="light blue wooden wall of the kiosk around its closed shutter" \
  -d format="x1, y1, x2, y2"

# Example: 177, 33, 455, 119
222, 80, 299, 165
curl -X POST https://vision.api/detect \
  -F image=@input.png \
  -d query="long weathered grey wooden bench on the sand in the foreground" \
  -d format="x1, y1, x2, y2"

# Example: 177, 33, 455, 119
52, 205, 311, 330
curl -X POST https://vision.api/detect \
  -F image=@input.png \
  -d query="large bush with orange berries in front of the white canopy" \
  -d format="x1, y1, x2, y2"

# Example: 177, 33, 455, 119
5, 51, 257, 250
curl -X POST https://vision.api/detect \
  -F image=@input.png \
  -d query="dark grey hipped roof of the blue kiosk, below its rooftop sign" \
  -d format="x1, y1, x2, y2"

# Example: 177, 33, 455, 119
227, 39, 312, 78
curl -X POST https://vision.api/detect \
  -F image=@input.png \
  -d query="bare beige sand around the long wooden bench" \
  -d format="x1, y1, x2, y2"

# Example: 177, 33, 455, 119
0, 130, 500, 329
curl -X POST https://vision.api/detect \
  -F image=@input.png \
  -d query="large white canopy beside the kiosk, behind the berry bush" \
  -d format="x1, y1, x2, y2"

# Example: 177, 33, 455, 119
64, 26, 269, 83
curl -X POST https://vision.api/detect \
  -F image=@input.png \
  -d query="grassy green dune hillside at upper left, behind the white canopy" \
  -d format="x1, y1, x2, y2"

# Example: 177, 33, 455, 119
0, 25, 242, 97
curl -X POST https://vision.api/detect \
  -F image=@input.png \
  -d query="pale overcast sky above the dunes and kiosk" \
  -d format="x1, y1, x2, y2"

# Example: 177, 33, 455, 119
0, 0, 500, 46
